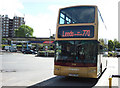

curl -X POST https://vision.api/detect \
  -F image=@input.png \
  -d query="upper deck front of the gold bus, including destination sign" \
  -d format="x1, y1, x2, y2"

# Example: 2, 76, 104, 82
56, 6, 98, 40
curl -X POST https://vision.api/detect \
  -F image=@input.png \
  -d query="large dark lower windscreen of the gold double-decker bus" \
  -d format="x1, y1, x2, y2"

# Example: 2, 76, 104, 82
56, 41, 98, 63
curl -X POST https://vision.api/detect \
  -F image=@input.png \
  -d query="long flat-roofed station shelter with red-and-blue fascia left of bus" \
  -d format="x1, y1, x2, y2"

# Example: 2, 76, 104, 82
3, 37, 54, 51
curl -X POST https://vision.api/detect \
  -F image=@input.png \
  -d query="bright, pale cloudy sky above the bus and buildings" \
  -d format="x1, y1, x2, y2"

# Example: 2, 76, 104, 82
0, 0, 120, 39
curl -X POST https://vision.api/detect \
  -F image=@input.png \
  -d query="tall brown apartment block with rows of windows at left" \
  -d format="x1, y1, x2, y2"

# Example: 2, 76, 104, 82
1, 15, 25, 37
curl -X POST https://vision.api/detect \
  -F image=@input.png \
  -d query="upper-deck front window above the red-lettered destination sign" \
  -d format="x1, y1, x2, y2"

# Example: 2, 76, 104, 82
59, 6, 95, 24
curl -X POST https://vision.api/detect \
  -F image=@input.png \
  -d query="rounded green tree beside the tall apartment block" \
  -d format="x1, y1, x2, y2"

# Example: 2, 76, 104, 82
15, 24, 33, 37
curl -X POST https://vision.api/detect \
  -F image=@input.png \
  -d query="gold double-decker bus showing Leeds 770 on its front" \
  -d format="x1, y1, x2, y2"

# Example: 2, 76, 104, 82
54, 5, 107, 78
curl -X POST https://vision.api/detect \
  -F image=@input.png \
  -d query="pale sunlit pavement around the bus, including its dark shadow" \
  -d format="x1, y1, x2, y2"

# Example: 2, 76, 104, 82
0, 52, 118, 88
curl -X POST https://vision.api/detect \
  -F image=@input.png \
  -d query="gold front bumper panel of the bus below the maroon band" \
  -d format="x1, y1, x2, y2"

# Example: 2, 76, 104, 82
54, 65, 98, 78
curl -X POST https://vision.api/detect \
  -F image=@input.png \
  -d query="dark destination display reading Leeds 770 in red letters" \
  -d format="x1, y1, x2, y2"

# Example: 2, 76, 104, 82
58, 26, 94, 38
